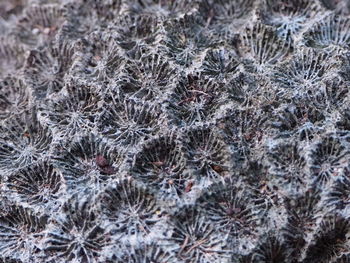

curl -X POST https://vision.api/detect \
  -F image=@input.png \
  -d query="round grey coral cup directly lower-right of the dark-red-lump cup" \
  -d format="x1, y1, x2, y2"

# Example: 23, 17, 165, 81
99, 178, 162, 240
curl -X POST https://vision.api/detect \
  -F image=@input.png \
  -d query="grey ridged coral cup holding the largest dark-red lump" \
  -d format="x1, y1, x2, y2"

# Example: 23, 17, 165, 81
54, 134, 124, 193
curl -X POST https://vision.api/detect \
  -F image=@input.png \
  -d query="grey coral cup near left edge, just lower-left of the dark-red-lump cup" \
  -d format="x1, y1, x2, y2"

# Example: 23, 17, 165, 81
6, 160, 63, 209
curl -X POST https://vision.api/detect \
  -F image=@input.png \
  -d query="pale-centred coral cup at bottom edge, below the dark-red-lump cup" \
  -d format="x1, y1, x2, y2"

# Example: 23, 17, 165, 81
44, 198, 110, 263
